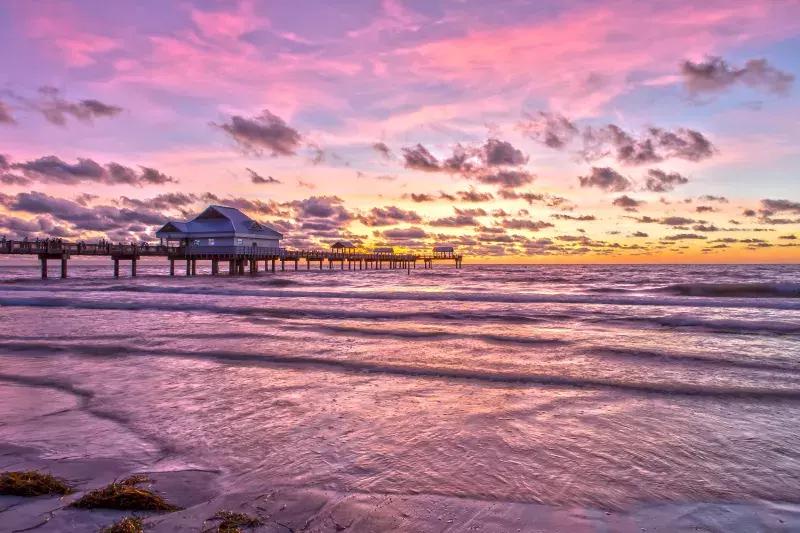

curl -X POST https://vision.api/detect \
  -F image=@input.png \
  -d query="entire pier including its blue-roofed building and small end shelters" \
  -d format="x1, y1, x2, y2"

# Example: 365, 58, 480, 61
0, 206, 463, 279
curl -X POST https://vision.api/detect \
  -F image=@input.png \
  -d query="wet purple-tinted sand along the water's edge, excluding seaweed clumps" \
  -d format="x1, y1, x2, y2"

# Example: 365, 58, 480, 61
0, 443, 800, 533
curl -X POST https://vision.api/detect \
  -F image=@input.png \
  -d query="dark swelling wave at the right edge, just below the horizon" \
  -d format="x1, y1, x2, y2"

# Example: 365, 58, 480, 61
589, 283, 800, 298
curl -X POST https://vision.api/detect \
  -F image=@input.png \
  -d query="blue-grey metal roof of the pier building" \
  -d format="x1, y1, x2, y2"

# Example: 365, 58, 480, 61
156, 205, 283, 239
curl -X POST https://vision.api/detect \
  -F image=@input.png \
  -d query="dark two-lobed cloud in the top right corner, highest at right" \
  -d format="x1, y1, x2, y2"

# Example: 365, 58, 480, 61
680, 57, 794, 96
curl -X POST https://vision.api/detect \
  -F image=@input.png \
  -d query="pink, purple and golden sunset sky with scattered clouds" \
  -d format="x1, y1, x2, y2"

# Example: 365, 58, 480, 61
0, 0, 800, 263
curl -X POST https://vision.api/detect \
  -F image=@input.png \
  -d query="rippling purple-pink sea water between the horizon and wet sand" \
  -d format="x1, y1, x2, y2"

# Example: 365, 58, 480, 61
0, 265, 800, 508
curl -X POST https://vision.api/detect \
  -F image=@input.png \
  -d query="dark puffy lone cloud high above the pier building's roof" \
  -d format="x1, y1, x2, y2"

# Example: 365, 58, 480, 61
212, 109, 303, 157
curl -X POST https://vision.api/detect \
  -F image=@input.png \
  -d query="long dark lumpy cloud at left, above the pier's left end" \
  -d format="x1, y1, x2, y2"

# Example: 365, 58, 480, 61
11, 155, 177, 187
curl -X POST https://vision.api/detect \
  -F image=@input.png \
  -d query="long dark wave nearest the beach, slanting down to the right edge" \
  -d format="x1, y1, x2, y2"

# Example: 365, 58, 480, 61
0, 343, 800, 401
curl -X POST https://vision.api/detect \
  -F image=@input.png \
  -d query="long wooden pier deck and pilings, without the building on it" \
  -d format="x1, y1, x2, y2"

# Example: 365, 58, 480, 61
0, 239, 463, 279
